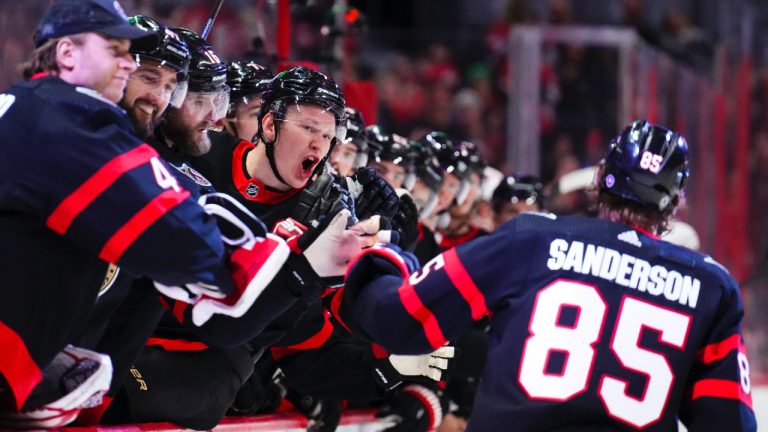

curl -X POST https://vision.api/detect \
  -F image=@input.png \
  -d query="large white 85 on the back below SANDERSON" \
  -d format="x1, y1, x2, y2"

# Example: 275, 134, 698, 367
518, 280, 691, 428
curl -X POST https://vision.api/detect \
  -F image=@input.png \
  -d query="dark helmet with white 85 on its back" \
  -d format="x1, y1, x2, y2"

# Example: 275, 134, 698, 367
599, 120, 689, 211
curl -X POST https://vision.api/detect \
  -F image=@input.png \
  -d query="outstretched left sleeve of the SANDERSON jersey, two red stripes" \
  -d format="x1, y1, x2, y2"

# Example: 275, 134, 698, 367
339, 219, 528, 354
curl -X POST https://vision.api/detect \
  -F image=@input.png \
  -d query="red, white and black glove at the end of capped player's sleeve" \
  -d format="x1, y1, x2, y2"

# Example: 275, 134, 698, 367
155, 193, 290, 326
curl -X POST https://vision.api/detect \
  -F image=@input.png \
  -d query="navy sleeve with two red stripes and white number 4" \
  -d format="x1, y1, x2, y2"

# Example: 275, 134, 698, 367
18, 102, 224, 285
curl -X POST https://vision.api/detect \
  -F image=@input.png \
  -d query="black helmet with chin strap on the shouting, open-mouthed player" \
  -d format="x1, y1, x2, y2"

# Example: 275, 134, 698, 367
256, 66, 347, 184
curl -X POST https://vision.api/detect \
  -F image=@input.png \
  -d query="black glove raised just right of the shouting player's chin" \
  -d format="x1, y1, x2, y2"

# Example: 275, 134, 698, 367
346, 167, 399, 220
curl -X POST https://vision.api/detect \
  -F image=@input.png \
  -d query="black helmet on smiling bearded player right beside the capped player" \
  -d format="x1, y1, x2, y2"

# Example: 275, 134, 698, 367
128, 15, 191, 82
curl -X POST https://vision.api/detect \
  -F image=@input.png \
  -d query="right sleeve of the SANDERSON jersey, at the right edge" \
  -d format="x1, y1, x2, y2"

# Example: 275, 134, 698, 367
680, 277, 757, 431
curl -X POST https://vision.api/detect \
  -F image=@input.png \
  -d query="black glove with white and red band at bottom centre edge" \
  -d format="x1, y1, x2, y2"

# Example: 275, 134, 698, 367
376, 384, 443, 432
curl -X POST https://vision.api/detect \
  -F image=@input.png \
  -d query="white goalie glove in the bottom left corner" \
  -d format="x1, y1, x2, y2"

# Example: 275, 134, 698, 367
0, 345, 112, 429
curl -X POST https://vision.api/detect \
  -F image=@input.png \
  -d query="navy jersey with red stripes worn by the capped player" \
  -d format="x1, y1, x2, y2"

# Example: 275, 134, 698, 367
0, 77, 225, 406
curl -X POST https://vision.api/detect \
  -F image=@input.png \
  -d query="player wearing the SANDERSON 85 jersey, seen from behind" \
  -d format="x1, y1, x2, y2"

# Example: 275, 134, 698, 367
342, 121, 756, 431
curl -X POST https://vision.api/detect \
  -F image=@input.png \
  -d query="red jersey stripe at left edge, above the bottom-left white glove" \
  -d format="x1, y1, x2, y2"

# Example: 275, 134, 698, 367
0, 321, 43, 410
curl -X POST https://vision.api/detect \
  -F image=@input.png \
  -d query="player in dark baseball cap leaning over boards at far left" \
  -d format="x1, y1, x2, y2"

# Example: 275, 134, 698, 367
0, 0, 284, 427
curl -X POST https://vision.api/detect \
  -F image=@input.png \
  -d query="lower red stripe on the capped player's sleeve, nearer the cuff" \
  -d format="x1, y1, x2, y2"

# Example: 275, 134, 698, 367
99, 189, 190, 264
